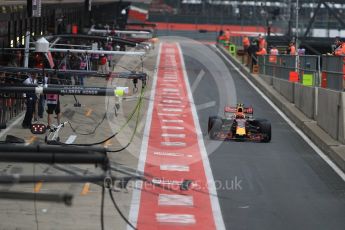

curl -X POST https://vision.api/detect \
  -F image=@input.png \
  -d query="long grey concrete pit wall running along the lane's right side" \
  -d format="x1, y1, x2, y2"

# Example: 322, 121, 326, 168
217, 45, 345, 171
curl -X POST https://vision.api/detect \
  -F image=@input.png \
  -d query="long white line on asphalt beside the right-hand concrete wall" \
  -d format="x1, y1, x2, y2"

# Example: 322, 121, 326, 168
213, 45, 345, 181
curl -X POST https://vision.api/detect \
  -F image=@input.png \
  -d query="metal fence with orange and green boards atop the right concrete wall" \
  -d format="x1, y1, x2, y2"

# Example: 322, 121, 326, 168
219, 41, 345, 91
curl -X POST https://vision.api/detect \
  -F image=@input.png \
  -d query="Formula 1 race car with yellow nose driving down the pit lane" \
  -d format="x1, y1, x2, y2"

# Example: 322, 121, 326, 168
208, 104, 271, 142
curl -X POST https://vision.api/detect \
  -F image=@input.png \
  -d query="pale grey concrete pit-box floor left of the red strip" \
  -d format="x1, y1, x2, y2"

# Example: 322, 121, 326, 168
0, 45, 157, 230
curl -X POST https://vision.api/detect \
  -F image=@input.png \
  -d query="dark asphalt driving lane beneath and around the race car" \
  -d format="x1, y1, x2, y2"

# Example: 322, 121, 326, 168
181, 44, 345, 230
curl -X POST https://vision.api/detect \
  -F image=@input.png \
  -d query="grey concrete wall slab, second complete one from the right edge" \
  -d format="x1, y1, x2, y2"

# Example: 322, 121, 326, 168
294, 83, 316, 119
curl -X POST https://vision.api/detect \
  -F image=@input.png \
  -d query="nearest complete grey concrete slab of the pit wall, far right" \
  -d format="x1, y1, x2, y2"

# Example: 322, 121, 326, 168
316, 88, 341, 140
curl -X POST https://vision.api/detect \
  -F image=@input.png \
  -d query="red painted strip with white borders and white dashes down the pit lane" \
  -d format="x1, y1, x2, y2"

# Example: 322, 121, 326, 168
128, 43, 225, 230
